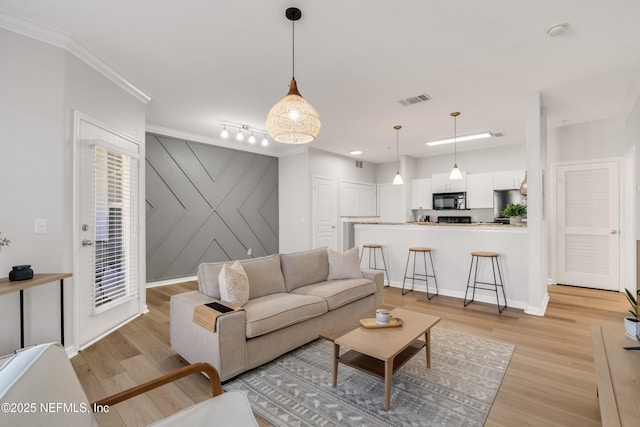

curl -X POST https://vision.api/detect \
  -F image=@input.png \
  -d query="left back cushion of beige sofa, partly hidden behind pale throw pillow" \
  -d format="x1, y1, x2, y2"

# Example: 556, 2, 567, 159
198, 255, 286, 299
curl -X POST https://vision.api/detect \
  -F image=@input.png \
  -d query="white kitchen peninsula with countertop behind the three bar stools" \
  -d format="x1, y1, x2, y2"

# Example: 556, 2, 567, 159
354, 222, 528, 309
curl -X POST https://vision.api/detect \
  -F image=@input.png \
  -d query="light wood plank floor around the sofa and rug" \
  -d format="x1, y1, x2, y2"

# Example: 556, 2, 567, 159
72, 282, 627, 427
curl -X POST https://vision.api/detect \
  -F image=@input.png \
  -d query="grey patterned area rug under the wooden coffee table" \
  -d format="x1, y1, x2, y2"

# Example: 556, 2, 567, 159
224, 328, 515, 427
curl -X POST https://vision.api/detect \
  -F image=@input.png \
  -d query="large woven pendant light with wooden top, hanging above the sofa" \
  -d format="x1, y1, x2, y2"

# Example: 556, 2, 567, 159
267, 7, 320, 144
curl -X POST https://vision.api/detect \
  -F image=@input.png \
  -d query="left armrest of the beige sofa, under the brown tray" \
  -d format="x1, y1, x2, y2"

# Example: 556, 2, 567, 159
170, 291, 247, 381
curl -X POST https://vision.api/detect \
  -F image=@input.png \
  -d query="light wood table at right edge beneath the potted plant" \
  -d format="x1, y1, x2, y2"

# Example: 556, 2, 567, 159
591, 326, 640, 427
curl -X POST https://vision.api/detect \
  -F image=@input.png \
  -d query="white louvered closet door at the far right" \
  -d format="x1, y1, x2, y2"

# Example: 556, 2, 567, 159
556, 161, 620, 290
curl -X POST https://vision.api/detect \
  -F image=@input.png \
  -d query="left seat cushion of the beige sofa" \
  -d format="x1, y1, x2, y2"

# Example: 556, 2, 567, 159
244, 293, 327, 338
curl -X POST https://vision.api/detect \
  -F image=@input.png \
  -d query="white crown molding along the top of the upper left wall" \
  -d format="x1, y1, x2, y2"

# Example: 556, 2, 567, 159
0, 10, 151, 104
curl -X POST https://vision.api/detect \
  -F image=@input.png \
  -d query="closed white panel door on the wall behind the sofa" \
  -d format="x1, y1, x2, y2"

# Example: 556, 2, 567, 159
313, 176, 338, 250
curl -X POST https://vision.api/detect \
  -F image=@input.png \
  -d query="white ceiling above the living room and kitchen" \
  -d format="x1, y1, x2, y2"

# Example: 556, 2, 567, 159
0, 0, 640, 163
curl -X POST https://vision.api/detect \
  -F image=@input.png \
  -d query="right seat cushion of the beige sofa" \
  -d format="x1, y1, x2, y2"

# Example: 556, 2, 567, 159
293, 278, 376, 311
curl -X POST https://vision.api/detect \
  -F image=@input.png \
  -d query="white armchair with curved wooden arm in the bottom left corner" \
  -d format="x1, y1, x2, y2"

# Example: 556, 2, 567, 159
0, 343, 258, 427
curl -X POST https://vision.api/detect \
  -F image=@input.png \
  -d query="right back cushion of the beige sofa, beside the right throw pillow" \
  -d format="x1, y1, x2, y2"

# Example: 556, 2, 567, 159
280, 247, 329, 292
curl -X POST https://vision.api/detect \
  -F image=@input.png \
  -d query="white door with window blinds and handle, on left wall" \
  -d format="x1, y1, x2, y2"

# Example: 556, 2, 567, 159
74, 118, 144, 349
